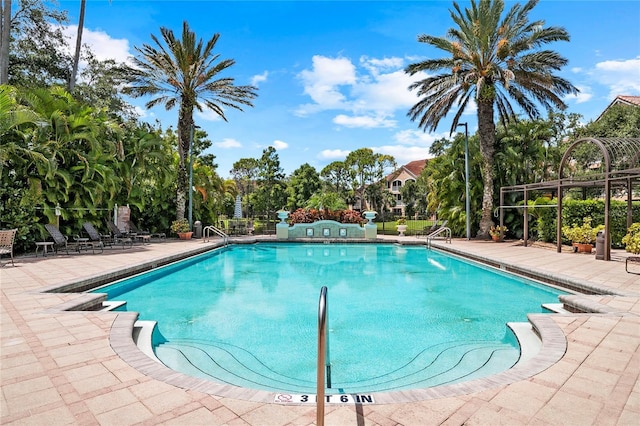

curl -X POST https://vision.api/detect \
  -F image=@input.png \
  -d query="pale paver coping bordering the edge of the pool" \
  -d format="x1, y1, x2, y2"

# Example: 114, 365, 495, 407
37, 238, 596, 405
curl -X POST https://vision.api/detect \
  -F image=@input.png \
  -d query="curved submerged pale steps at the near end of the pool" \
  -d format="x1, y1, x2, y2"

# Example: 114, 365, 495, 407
156, 341, 518, 393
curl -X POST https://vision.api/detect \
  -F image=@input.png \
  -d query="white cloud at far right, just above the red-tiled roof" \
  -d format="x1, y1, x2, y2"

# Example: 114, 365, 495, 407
593, 56, 640, 98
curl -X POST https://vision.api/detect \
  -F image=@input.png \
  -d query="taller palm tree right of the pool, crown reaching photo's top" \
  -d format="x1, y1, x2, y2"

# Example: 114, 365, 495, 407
405, 0, 578, 237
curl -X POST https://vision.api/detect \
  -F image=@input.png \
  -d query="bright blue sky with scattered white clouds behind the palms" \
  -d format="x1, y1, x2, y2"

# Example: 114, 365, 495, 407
55, 0, 640, 177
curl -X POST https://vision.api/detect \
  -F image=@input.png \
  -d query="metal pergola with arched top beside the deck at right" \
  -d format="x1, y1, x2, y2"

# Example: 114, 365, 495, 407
499, 138, 640, 260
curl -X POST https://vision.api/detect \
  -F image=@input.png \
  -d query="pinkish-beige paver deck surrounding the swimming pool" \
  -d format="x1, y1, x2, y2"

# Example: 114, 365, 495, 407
0, 237, 640, 425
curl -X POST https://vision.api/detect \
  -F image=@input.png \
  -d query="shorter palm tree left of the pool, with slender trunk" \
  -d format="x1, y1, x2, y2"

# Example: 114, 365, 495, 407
126, 21, 257, 219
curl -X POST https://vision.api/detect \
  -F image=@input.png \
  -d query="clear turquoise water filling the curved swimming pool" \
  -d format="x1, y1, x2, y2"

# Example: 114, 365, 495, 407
96, 243, 562, 393
